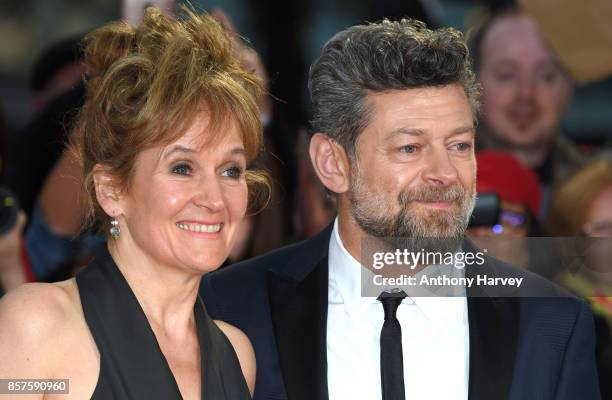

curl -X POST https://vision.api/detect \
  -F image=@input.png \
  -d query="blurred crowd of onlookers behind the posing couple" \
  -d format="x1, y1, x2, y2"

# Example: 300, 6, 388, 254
0, 0, 612, 399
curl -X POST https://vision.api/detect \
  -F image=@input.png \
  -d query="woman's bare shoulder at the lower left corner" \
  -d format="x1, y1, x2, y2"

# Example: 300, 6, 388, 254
0, 279, 100, 399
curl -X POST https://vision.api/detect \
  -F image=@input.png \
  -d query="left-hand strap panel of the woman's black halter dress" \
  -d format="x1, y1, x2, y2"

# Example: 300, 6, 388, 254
76, 248, 181, 400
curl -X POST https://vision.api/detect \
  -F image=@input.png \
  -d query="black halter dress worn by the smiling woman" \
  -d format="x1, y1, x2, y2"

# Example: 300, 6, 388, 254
76, 249, 251, 400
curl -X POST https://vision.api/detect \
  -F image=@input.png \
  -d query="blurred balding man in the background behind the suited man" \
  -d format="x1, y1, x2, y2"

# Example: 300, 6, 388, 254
472, 9, 585, 216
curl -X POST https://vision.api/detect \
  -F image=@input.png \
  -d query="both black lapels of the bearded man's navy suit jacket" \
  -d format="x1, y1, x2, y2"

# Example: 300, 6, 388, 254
267, 231, 520, 400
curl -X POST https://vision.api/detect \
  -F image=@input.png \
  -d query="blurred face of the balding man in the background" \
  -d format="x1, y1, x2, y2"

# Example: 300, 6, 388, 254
478, 15, 572, 148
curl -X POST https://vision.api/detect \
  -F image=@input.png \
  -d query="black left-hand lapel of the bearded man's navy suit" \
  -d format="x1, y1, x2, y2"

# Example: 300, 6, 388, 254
268, 256, 328, 400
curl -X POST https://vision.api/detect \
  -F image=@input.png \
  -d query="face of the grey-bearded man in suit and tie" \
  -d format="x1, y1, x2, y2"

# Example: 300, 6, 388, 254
349, 85, 476, 242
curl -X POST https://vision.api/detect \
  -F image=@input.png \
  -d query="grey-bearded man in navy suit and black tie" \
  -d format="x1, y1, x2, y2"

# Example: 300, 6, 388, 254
201, 20, 599, 400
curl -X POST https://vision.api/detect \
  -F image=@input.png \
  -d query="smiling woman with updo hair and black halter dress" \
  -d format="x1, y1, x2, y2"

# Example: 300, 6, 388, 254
0, 8, 266, 400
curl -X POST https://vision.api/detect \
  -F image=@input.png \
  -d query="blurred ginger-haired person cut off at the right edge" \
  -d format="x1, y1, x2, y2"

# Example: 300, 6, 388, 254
546, 159, 612, 399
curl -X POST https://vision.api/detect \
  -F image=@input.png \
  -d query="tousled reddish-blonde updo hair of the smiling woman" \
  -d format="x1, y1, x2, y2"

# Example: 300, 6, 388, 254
70, 7, 269, 228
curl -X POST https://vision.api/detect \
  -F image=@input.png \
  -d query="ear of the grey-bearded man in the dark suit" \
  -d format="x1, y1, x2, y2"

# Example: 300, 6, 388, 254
309, 133, 350, 193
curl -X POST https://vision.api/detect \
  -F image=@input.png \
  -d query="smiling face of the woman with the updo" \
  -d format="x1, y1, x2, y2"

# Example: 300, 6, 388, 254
119, 112, 248, 273
